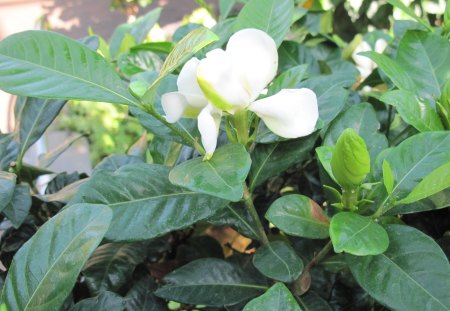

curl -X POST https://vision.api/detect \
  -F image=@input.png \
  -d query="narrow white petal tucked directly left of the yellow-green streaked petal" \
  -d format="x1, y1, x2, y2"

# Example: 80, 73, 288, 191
177, 57, 208, 108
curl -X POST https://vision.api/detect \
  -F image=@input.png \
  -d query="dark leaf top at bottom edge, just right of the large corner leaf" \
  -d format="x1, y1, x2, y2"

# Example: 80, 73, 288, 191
70, 291, 126, 311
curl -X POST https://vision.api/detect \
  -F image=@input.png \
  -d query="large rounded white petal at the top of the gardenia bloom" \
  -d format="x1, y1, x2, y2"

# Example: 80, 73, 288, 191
226, 28, 278, 102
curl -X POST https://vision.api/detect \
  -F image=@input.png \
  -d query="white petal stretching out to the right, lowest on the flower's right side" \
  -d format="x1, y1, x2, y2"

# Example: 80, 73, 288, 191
249, 88, 319, 138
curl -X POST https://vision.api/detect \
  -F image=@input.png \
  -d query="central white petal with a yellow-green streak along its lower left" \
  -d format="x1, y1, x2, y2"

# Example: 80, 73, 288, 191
197, 49, 250, 112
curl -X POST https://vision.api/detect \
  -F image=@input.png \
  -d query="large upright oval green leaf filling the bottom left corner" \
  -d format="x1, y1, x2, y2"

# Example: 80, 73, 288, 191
2, 204, 111, 311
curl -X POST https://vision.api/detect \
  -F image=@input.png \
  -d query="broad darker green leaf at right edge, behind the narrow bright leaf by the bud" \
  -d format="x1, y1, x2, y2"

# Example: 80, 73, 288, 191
372, 132, 450, 215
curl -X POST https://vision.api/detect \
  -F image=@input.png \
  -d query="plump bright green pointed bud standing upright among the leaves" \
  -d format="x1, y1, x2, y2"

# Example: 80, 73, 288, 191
331, 129, 370, 190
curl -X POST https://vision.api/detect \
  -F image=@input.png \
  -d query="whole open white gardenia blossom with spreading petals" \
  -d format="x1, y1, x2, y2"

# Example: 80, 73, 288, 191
162, 29, 319, 155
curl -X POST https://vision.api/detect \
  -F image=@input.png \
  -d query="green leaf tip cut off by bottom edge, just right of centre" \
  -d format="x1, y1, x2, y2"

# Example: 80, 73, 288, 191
244, 283, 302, 311
